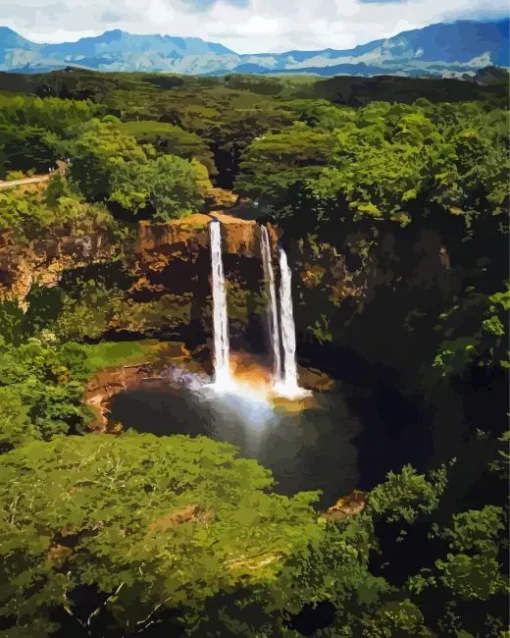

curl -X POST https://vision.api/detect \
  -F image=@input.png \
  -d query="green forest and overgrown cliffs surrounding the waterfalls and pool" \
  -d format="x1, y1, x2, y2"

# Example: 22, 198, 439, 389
0, 69, 510, 638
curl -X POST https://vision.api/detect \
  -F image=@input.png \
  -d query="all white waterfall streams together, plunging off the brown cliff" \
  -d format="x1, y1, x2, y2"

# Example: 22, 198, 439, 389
209, 220, 308, 398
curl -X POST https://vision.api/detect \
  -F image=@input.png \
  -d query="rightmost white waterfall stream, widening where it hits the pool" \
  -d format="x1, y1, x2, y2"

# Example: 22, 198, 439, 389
275, 246, 309, 398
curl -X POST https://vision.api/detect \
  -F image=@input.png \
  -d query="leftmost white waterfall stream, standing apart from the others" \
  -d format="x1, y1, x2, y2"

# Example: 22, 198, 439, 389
209, 219, 232, 389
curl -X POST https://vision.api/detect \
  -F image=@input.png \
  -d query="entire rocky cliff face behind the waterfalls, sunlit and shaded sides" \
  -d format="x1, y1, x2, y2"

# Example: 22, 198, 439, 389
0, 212, 454, 380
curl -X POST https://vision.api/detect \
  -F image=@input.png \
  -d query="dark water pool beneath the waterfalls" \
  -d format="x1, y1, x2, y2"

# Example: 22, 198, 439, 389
111, 386, 428, 507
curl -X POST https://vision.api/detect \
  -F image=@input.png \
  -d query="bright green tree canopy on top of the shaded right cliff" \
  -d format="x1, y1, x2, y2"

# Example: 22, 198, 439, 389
236, 102, 509, 224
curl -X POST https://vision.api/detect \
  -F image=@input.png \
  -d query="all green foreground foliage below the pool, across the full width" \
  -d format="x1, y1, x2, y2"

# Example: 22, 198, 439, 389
0, 433, 508, 638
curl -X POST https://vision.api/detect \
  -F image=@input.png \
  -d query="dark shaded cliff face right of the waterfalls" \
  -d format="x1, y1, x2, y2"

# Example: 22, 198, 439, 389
288, 226, 456, 384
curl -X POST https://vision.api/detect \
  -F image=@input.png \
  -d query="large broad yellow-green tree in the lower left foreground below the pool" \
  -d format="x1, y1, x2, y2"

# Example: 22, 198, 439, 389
0, 434, 320, 638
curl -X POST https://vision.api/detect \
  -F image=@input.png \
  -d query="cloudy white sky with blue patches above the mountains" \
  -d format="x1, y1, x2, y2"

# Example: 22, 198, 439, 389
0, 0, 508, 53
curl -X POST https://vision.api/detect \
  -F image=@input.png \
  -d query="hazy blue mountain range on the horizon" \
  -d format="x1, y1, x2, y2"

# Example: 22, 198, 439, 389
0, 18, 510, 77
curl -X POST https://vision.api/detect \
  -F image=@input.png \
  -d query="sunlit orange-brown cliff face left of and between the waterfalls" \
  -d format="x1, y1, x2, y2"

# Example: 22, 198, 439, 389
0, 213, 277, 349
